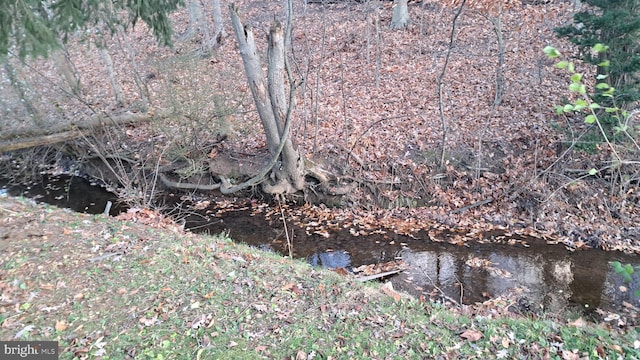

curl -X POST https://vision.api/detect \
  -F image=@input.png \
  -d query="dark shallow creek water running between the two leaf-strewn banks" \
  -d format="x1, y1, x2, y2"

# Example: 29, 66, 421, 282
3, 176, 640, 311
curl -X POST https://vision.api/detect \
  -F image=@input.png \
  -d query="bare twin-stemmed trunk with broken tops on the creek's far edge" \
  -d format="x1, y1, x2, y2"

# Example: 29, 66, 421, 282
229, 5, 304, 194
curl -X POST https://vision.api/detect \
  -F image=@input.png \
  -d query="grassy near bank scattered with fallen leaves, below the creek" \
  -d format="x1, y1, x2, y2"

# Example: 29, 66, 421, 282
0, 197, 640, 359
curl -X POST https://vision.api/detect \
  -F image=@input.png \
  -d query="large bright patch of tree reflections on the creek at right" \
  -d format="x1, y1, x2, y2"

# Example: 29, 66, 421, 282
392, 246, 640, 311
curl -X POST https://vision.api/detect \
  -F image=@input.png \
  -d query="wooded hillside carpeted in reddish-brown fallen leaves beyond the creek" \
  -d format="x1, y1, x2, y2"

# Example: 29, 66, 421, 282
0, 1, 640, 253
